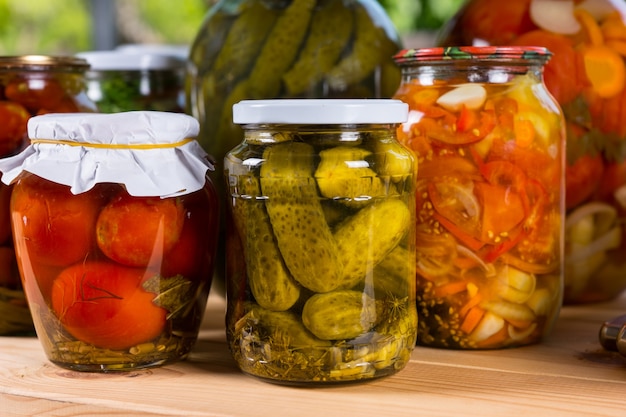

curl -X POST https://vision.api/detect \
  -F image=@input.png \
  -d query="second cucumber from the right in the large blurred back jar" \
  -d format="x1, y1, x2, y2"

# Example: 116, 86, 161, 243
283, 0, 353, 96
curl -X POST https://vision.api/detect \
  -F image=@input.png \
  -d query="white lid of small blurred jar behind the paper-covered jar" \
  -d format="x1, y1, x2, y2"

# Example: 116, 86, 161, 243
76, 51, 185, 71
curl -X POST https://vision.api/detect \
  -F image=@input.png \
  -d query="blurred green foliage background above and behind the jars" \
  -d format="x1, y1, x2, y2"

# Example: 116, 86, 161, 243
0, 0, 463, 55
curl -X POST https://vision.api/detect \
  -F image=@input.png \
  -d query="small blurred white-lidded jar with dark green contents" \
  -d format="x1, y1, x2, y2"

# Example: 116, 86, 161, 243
78, 49, 185, 113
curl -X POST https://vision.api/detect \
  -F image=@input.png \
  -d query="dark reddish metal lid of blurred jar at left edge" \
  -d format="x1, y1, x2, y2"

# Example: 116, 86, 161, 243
0, 55, 89, 72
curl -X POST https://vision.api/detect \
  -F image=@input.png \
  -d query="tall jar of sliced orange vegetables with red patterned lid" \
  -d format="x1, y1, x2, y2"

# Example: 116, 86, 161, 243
395, 47, 565, 349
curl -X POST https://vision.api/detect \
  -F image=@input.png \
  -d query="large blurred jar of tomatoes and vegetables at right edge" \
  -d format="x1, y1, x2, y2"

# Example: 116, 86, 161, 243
439, 0, 626, 304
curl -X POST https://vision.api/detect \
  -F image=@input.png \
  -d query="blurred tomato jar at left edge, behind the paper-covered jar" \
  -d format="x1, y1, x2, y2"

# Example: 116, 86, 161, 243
0, 55, 95, 335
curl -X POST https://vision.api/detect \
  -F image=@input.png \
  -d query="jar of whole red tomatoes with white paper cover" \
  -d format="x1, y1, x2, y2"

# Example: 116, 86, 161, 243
0, 112, 218, 372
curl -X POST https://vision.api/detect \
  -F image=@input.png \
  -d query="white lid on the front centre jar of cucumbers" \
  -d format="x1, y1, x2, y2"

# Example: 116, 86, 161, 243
233, 99, 409, 124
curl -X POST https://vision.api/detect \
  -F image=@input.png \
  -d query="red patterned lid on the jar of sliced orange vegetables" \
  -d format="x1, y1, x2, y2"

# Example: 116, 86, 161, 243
393, 46, 552, 65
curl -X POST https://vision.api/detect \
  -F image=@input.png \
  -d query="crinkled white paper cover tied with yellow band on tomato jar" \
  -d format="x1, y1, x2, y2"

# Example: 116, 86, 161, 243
0, 111, 214, 197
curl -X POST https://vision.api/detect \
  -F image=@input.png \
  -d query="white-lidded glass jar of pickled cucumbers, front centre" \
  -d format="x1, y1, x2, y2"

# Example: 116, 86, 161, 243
224, 99, 417, 384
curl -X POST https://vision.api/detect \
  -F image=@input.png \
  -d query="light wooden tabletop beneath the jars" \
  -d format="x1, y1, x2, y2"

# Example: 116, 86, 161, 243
0, 290, 626, 417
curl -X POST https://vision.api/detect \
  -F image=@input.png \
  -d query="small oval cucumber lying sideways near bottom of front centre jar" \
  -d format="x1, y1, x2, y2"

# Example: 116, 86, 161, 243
302, 290, 379, 340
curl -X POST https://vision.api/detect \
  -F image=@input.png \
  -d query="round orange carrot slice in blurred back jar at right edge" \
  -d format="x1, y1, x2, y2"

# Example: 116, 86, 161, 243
583, 45, 626, 98
